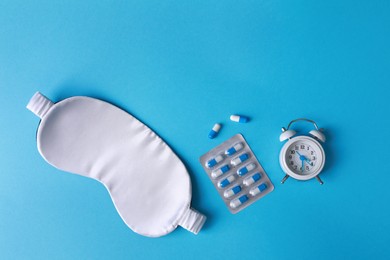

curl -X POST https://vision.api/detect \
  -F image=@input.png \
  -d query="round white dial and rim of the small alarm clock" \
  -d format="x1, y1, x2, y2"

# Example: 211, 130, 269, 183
280, 136, 325, 180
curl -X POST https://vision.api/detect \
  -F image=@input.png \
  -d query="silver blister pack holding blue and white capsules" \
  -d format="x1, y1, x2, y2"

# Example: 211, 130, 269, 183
200, 134, 274, 214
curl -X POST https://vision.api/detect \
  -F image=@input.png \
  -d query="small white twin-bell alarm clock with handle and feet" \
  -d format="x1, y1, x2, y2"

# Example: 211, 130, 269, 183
279, 118, 326, 184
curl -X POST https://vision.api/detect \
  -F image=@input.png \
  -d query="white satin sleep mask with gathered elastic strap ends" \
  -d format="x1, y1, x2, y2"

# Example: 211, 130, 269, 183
27, 92, 206, 237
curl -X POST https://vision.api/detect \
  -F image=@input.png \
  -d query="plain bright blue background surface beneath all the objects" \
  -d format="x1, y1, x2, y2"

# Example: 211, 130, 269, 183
0, 0, 390, 259
